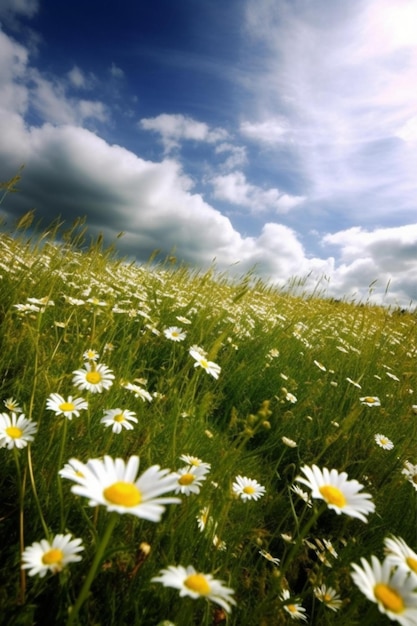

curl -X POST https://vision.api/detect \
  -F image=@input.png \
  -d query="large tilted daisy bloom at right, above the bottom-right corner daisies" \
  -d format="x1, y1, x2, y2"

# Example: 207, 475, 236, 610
296, 465, 375, 522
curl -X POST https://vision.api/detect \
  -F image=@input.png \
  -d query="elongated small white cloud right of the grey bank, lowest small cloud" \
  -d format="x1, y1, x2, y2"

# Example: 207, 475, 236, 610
211, 171, 304, 213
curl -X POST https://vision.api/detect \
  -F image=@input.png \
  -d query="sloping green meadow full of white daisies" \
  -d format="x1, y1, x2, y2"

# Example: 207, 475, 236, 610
0, 212, 417, 626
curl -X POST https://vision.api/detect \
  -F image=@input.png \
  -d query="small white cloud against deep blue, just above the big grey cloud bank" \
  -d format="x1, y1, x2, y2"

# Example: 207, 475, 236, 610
139, 113, 228, 153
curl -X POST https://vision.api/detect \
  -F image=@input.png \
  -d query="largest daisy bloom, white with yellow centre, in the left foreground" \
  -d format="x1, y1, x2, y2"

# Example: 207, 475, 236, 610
62, 456, 181, 522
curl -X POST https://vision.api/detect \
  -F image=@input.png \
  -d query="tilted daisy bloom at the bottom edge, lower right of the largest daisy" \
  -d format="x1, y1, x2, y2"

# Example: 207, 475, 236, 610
151, 565, 236, 612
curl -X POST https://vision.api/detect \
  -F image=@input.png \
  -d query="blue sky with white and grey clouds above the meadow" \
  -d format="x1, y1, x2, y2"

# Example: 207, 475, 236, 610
0, 0, 417, 308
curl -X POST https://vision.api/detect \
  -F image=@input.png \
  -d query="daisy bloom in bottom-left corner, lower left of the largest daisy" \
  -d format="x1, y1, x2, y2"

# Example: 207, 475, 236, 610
22, 534, 84, 578
